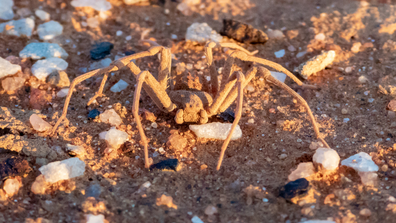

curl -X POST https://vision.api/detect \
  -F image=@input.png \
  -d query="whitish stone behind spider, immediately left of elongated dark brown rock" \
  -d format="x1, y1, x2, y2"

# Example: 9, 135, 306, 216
186, 23, 223, 43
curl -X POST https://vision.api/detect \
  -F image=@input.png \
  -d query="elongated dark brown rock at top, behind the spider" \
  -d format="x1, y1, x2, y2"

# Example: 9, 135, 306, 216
220, 19, 268, 43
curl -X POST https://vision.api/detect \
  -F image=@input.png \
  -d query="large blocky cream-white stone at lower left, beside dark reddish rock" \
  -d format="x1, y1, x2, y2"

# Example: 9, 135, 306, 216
39, 157, 85, 183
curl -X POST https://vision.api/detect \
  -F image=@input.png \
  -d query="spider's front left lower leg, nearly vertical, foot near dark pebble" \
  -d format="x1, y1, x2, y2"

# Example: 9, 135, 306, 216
132, 71, 153, 168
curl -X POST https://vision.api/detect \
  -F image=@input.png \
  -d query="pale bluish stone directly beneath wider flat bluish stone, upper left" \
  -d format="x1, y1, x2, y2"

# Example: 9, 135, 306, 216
32, 57, 69, 81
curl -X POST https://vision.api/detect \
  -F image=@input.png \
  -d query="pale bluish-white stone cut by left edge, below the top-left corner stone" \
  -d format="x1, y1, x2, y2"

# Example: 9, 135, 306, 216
0, 18, 35, 38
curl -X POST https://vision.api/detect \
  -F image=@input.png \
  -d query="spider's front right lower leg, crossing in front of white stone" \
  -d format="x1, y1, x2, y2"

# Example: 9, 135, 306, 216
216, 71, 245, 170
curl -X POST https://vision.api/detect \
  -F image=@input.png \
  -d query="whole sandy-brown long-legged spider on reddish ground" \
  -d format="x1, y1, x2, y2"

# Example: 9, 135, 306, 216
50, 41, 330, 170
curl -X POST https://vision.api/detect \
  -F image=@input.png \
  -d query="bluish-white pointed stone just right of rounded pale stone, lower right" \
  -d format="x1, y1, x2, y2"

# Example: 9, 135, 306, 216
341, 152, 378, 172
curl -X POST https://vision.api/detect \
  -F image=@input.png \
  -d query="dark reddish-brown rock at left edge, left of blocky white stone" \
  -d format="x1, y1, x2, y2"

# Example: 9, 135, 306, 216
0, 157, 32, 180
